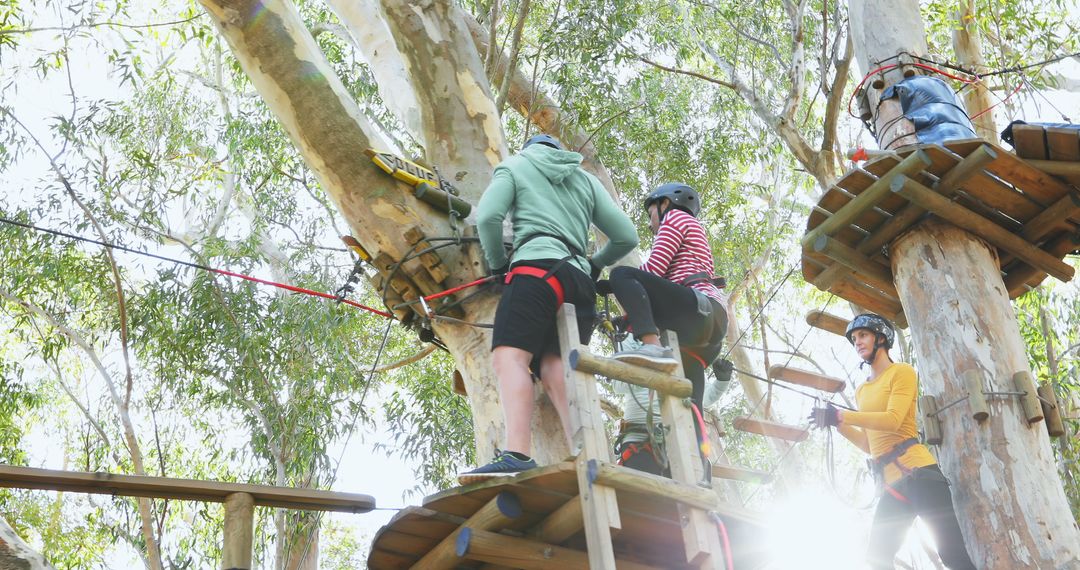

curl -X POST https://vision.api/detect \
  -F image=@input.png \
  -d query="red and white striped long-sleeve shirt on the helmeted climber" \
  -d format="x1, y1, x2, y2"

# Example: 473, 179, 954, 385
640, 208, 724, 303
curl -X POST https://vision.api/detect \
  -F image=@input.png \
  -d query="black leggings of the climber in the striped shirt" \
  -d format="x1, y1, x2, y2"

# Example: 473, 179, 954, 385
609, 266, 728, 409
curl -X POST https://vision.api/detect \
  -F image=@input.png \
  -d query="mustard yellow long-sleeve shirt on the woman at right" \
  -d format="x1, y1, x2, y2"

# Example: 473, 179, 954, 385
838, 363, 936, 485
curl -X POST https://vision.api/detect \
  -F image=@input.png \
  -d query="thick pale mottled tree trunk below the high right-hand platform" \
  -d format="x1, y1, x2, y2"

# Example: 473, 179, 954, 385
891, 219, 1080, 569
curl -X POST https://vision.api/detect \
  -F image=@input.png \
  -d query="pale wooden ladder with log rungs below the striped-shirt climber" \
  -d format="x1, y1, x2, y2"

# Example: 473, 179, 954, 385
557, 303, 727, 569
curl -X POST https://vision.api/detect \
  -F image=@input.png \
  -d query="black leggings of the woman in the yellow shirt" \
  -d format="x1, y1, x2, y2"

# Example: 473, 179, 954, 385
867, 465, 975, 570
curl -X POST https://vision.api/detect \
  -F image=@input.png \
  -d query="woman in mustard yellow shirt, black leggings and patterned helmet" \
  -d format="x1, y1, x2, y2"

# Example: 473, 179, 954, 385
810, 313, 975, 570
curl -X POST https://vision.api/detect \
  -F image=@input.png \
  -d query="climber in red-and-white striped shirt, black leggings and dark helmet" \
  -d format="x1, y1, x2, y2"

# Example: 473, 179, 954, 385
602, 182, 728, 416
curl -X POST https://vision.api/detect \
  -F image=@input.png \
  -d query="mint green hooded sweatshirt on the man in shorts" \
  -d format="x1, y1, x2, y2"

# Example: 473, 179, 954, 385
476, 145, 637, 275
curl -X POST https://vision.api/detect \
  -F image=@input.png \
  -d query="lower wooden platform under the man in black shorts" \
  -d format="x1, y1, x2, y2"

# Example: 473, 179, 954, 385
367, 462, 766, 570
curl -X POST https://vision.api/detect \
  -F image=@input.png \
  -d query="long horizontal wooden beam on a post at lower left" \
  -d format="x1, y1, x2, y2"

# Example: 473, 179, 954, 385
0, 465, 375, 513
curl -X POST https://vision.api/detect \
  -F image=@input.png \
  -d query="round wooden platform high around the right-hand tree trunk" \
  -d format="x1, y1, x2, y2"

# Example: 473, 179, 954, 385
802, 136, 1080, 317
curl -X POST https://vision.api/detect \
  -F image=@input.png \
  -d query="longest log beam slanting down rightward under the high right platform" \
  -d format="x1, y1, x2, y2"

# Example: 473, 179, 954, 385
892, 177, 1075, 282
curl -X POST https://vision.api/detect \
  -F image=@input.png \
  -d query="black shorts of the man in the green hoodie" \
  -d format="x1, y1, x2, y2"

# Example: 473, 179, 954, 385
491, 259, 596, 375
